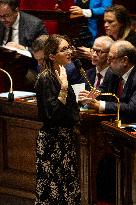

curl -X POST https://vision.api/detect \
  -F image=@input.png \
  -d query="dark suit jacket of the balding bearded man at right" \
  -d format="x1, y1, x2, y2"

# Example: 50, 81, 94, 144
100, 66, 136, 123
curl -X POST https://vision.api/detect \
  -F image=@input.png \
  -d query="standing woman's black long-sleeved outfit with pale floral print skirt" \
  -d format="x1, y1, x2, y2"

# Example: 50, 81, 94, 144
35, 71, 81, 205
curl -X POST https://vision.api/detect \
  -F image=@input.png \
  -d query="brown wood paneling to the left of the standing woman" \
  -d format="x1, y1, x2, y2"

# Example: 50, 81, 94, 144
0, 99, 42, 205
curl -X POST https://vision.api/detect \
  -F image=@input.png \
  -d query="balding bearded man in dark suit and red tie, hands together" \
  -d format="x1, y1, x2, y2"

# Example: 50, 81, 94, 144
79, 40, 136, 123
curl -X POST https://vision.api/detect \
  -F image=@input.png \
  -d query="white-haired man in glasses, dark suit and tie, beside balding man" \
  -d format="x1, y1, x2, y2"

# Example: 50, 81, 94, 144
75, 36, 114, 90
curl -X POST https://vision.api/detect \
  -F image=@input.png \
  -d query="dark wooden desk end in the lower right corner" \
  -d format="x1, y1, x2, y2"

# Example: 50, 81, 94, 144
102, 122, 136, 205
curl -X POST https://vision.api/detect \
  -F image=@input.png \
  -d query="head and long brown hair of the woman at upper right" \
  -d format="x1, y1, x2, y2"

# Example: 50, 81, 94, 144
104, 4, 136, 46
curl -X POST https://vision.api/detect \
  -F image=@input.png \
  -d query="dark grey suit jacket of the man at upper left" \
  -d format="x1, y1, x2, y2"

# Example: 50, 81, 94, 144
0, 12, 47, 47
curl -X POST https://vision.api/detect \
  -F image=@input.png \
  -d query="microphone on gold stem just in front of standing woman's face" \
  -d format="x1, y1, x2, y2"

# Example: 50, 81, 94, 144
74, 58, 96, 90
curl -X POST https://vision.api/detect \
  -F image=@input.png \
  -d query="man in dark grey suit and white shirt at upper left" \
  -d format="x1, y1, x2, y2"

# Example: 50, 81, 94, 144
0, 0, 47, 50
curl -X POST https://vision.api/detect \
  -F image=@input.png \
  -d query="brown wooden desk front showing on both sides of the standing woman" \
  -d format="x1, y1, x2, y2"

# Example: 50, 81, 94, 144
0, 99, 113, 205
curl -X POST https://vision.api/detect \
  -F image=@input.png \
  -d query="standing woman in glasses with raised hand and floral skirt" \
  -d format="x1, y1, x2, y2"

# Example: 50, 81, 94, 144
35, 34, 80, 205
